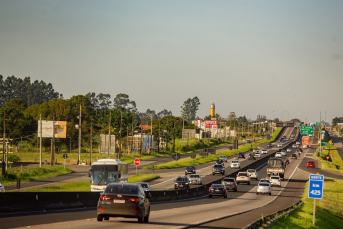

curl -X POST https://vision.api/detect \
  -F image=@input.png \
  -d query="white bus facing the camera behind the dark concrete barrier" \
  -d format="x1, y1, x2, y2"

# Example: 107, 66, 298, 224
89, 159, 128, 192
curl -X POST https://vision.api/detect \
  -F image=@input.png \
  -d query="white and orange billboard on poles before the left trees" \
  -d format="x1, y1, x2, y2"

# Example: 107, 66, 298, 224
38, 120, 67, 138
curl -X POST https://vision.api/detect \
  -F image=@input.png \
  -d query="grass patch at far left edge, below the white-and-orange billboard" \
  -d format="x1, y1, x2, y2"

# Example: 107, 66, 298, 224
0, 166, 75, 185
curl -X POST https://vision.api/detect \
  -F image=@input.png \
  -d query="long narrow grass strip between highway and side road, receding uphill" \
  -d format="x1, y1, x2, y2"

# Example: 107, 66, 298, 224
143, 128, 281, 170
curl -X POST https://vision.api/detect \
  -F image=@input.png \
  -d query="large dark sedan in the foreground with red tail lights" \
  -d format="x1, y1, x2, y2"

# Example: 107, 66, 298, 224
97, 183, 150, 223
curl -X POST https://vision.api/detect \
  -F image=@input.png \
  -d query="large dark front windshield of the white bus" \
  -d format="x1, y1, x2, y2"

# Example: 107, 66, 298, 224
91, 165, 118, 185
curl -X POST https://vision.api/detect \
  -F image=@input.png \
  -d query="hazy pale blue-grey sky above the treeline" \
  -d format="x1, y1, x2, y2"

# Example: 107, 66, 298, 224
0, 0, 343, 122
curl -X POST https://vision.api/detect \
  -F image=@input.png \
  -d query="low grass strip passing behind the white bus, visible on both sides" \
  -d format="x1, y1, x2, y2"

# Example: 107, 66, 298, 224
25, 174, 160, 192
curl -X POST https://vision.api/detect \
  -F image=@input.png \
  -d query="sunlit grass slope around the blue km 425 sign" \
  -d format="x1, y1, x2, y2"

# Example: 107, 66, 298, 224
272, 179, 343, 229
